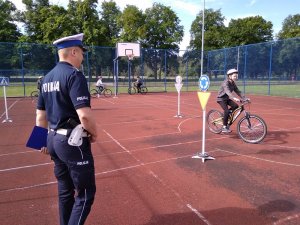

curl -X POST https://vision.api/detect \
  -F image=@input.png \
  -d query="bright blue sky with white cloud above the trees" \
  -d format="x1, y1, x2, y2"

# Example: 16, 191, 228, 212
12, 0, 300, 50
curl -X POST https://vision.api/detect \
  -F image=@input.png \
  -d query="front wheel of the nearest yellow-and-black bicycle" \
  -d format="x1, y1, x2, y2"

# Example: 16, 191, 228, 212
237, 115, 267, 144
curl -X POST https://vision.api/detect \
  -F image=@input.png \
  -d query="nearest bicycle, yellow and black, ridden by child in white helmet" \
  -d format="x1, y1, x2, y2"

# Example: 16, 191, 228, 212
206, 99, 267, 144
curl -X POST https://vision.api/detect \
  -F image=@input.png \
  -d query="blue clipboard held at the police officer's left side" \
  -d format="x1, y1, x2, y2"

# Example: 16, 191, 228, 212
26, 126, 48, 150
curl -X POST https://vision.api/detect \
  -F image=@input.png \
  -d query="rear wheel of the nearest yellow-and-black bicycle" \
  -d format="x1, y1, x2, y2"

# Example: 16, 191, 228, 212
206, 109, 223, 134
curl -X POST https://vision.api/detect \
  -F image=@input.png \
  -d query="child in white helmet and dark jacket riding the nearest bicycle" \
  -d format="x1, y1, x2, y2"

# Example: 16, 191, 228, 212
217, 69, 244, 133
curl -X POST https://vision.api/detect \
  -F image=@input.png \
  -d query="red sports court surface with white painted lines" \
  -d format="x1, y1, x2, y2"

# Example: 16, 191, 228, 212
0, 92, 300, 225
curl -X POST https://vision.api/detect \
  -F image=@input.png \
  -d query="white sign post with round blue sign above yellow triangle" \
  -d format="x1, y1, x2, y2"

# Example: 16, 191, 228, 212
192, 75, 215, 162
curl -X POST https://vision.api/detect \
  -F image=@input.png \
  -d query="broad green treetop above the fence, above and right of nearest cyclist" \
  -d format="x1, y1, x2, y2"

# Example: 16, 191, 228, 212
226, 16, 273, 47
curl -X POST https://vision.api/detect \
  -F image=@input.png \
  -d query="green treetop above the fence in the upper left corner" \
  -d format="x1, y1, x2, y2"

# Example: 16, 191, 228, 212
0, 0, 21, 42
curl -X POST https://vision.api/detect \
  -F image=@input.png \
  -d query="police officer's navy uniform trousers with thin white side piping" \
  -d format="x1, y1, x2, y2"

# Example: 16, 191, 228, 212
47, 131, 96, 225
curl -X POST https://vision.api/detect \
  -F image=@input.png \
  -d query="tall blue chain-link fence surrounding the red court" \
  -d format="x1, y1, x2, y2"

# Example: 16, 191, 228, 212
0, 38, 300, 97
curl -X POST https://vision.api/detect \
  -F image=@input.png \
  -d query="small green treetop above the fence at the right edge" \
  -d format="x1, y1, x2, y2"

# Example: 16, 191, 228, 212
277, 14, 300, 39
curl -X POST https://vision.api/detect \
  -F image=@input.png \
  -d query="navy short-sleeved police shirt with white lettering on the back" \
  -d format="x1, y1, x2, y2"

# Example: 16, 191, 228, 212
37, 62, 91, 130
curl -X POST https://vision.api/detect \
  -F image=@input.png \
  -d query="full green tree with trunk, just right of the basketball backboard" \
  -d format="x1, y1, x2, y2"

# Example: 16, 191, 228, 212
140, 3, 183, 79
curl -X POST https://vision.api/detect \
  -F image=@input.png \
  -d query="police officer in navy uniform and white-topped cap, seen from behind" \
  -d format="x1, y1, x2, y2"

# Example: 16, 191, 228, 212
36, 34, 97, 225
